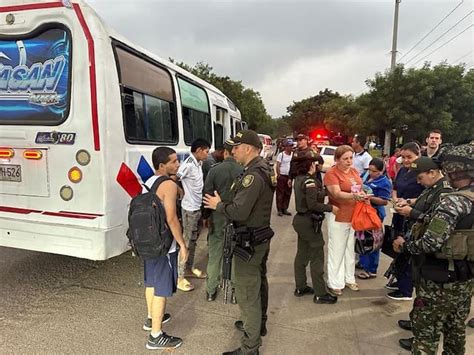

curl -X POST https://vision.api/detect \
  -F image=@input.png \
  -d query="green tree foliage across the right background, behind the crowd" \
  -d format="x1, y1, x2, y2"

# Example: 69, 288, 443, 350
287, 63, 474, 143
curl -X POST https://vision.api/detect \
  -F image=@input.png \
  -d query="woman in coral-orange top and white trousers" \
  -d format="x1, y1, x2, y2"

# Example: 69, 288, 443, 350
324, 145, 365, 295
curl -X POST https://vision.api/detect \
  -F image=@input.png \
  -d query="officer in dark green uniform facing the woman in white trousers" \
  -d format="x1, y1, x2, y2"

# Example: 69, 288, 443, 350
293, 160, 338, 304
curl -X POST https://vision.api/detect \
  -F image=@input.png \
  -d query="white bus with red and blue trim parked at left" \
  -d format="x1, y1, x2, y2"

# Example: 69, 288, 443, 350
0, 0, 246, 260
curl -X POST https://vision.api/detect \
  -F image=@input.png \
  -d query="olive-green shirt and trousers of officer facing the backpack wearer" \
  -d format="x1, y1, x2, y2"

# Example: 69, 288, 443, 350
216, 157, 276, 354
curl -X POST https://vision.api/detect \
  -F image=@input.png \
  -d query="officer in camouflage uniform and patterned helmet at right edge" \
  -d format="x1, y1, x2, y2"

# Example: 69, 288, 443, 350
394, 144, 474, 354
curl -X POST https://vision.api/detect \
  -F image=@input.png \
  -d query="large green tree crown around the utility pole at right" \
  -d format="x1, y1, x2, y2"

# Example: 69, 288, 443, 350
357, 63, 474, 142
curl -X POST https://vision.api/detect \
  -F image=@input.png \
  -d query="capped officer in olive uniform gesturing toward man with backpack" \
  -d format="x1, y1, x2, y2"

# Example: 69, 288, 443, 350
204, 130, 276, 354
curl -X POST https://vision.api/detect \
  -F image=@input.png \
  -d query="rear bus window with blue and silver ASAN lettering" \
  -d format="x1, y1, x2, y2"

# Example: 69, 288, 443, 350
0, 25, 71, 125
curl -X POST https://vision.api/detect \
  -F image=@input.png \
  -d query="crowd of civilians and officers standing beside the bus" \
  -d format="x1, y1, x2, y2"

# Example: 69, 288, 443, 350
136, 130, 474, 354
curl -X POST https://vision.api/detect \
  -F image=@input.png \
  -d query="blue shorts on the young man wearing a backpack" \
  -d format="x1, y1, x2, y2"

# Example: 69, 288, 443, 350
144, 251, 178, 297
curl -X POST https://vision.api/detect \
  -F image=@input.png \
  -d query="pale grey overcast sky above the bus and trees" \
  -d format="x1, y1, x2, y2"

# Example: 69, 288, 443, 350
89, 0, 474, 117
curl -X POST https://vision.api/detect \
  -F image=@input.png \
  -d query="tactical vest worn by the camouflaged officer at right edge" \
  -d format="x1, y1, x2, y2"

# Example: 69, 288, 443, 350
435, 190, 474, 271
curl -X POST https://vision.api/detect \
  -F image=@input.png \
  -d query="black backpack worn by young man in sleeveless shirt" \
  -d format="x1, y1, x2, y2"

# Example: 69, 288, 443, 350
127, 176, 173, 260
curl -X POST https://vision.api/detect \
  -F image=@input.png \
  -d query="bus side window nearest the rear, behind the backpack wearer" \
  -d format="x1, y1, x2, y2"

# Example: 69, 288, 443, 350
115, 47, 178, 144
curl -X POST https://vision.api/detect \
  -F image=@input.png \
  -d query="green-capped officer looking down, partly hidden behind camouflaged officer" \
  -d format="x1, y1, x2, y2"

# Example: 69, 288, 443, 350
395, 157, 452, 350
